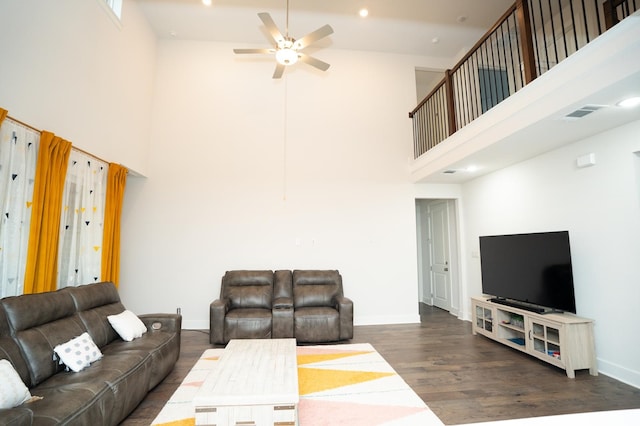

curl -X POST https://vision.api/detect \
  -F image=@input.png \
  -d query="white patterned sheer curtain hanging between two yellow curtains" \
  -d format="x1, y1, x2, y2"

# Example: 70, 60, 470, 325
58, 149, 109, 288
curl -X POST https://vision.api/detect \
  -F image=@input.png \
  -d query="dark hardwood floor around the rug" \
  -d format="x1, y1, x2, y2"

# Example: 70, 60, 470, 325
122, 306, 640, 426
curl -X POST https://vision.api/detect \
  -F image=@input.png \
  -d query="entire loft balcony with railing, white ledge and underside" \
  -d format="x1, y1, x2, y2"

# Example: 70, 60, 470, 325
409, 0, 640, 183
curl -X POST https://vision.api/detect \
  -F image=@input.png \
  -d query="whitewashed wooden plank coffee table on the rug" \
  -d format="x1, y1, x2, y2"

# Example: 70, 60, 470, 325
193, 339, 299, 426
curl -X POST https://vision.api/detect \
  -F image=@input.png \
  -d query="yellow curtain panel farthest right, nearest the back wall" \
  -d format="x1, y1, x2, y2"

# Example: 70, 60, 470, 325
102, 163, 127, 287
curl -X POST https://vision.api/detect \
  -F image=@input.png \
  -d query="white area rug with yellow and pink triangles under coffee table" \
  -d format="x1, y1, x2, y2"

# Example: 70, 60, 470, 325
152, 343, 443, 426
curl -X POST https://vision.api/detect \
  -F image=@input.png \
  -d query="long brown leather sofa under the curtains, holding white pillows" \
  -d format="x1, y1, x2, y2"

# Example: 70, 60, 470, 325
0, 283, 182, 425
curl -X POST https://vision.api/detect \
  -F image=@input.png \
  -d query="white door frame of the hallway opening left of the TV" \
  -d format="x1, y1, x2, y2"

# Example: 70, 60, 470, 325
416, 198, 463, 317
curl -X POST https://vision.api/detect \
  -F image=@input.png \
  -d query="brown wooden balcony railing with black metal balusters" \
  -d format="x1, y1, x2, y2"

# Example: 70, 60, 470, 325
409, 0, 640, 158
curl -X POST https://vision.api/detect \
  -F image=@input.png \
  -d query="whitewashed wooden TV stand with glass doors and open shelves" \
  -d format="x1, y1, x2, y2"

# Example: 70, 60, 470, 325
471, 296, 598, 378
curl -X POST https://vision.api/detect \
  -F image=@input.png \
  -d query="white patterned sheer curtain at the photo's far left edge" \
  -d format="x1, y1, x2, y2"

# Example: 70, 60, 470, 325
0, 118, 40, 297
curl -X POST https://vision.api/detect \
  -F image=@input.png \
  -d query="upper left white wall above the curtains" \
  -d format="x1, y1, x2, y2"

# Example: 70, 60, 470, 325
0, 0, 155, 173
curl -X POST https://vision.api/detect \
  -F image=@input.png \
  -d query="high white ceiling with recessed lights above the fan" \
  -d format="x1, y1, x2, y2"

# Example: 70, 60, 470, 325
136, 0, 514, 64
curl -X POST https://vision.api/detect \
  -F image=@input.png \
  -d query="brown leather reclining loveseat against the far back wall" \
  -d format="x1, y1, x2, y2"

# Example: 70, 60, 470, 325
209, 270, 353, 345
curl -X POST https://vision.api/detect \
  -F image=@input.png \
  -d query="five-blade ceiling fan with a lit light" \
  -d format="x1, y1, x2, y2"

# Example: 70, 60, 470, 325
233, 0, 333, 78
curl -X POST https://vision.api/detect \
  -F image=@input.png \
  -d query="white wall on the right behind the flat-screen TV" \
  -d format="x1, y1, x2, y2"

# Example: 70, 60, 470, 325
463, 121, 640, 387
